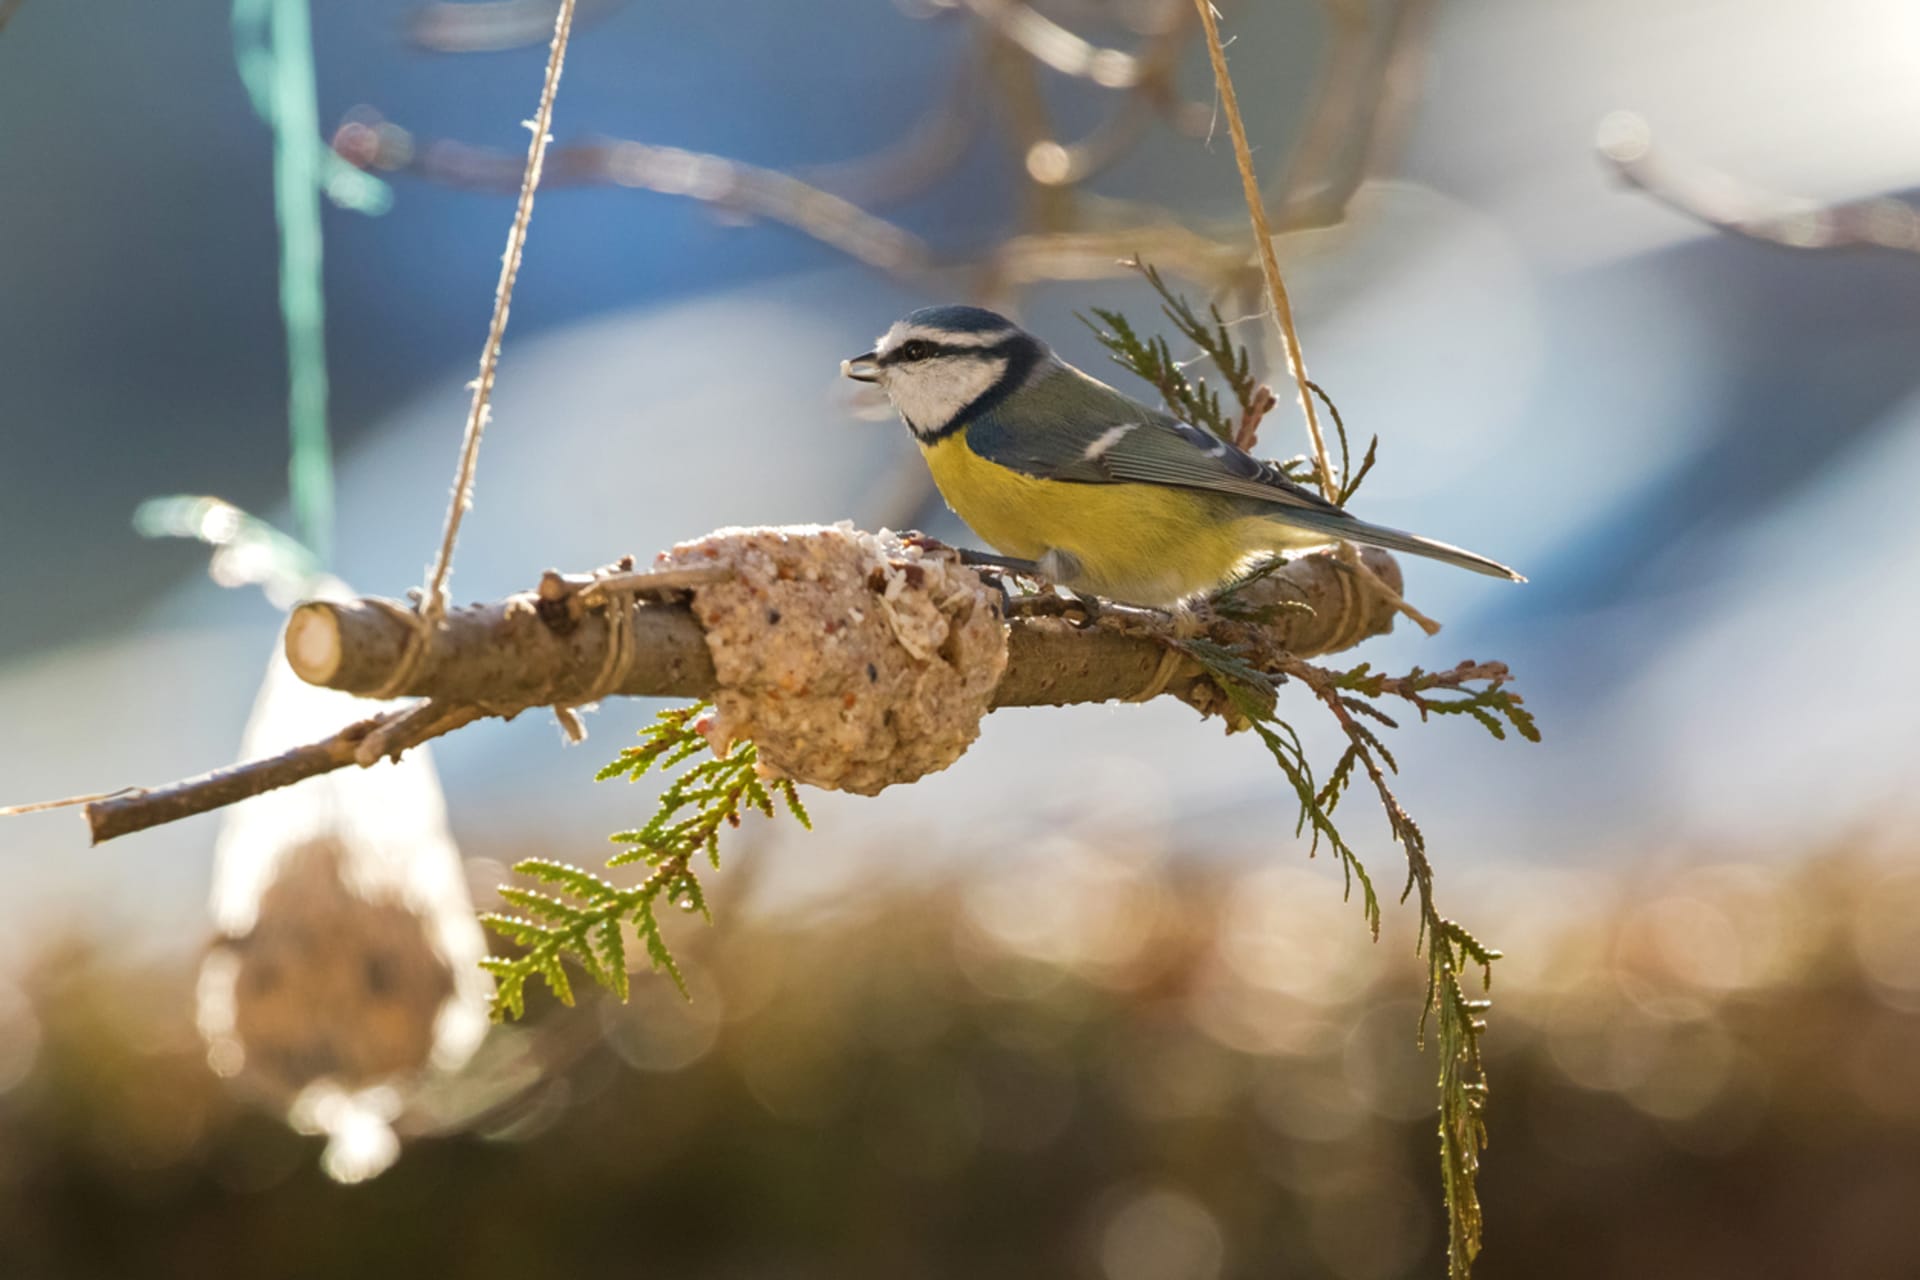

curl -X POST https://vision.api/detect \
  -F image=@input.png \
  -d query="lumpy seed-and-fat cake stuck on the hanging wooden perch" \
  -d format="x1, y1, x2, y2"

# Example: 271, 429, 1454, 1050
659, 522, 1006, 794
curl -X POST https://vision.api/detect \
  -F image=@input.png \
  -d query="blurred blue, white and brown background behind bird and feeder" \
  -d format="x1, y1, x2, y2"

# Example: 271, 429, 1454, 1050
0, 0, 1920, 1280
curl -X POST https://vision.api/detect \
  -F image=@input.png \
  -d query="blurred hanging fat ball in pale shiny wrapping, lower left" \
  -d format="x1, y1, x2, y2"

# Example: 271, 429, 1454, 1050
198, 579, 488, 1182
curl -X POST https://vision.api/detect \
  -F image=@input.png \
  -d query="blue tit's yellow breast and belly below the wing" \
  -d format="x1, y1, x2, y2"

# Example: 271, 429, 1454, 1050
920, 428, 1271, 604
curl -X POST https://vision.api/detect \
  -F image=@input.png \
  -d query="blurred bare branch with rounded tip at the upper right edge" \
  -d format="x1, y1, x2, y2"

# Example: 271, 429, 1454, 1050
1596, 111, 1920, 253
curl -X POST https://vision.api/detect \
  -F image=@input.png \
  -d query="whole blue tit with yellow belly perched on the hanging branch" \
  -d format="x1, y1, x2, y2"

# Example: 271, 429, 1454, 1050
841, 307, 1524, 606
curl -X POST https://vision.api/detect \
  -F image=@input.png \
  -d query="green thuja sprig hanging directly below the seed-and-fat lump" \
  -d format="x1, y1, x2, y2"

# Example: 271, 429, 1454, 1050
480, 702, 812, 1019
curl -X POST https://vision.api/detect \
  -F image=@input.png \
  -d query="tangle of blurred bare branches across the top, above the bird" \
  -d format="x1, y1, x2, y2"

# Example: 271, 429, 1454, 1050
332, 0, 1432, 305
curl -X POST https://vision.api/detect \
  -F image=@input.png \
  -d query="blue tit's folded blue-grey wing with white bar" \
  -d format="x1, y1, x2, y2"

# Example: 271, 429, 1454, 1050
968, 370, 1346, 516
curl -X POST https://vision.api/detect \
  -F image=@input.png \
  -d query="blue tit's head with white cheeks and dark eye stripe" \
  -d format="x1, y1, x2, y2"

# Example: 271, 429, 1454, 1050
841, 307, 1050, 439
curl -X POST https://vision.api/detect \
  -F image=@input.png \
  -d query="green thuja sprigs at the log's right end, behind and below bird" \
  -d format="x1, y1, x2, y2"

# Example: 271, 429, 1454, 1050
1089, 263, 1540, 1278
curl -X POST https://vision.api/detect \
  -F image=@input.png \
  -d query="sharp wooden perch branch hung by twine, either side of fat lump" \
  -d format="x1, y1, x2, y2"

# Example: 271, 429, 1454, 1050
21, 547, 1402, 844
